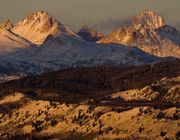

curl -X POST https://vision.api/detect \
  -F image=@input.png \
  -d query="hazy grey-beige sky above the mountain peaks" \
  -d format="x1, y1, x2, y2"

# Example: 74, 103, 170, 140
0, 0, 180, 31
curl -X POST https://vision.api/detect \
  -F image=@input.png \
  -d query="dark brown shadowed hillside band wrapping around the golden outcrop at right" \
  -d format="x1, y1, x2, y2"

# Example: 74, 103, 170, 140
0, 60, 180, 110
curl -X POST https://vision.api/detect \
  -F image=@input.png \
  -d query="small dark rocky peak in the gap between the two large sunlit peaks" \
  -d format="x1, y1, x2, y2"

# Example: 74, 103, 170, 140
78, 25, 104, 42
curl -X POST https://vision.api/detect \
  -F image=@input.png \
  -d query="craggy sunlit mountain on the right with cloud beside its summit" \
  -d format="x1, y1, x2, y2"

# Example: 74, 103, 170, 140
98, 10, 180, 58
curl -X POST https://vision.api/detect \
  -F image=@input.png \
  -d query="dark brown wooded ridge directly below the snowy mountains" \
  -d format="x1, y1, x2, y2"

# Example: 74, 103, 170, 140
0, 60, 180, 100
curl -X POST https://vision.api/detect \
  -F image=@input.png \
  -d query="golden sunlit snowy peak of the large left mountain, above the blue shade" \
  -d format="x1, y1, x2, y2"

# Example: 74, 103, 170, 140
12, 11, 78, 44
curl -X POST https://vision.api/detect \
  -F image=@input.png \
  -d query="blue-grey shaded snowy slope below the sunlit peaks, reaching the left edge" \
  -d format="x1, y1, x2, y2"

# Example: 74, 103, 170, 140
0, 34, 159, 80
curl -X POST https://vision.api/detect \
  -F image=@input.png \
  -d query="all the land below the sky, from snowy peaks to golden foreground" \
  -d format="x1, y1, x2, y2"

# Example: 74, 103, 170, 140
0, 10, 180, 140
